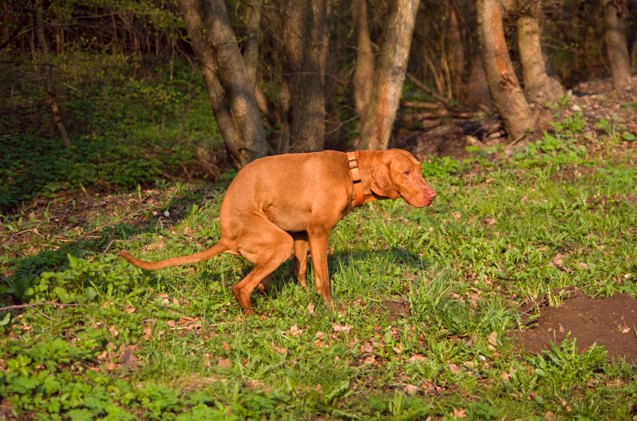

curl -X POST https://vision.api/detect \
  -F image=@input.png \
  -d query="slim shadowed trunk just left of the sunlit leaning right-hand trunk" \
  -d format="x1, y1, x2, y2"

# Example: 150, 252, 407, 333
446, 0, 465, 99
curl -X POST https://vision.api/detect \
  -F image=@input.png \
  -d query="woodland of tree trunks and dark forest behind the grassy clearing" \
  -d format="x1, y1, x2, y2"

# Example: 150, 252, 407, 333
0, 0, 637, 183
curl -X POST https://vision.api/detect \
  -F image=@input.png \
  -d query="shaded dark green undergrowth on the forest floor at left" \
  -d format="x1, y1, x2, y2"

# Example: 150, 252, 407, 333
0, 53, 221, 212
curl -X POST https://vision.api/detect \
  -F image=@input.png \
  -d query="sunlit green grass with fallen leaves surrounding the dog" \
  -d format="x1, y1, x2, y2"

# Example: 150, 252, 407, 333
0, 134, 637, 419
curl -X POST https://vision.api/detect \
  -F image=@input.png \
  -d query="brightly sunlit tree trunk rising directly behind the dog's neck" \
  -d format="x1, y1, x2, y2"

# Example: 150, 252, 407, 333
358, 0, 420, 149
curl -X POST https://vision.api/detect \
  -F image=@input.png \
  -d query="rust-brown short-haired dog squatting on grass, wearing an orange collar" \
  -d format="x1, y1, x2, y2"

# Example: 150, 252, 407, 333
120, 149, 436, 314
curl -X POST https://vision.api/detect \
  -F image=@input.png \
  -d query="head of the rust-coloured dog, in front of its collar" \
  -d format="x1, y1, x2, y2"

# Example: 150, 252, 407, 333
371, 149, 436, 208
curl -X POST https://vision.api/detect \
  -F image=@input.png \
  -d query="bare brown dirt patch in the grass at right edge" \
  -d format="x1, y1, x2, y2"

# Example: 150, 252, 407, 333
514, 291, 637, 363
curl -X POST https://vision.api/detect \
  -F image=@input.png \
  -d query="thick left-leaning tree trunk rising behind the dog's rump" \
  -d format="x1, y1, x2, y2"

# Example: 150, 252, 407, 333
177, 0, 267, 167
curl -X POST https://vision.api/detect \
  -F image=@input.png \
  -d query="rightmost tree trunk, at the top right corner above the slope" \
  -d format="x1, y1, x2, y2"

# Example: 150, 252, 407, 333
602, 0, 630, 92
